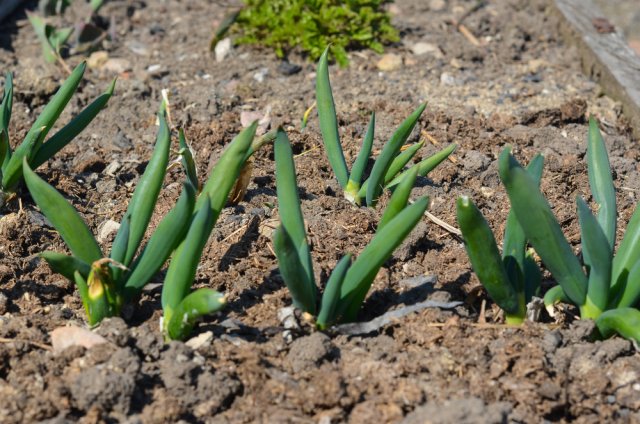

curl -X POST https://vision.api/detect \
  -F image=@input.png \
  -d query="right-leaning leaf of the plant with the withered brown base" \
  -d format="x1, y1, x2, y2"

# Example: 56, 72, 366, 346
118, 183, 196, 299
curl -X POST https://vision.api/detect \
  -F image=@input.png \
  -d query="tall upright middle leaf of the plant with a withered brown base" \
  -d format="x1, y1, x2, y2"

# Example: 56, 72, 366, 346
111, 113, 171, 266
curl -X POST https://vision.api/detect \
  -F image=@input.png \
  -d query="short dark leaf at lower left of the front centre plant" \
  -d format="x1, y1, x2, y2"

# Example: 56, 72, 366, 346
273, 224, 316, 315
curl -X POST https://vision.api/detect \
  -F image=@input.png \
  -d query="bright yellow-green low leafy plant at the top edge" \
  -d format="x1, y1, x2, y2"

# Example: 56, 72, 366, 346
234, 0, 400, 66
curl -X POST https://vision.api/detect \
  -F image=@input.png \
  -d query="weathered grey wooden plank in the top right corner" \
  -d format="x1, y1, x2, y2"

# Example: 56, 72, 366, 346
553, 0, 640, 137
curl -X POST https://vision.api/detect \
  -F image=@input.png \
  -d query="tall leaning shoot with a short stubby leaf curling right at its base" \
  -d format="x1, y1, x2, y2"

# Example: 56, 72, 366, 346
162, 122, 265, 340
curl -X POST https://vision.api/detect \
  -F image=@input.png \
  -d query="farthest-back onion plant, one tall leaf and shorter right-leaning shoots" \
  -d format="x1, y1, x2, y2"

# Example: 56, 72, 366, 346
316, 49, 456, 207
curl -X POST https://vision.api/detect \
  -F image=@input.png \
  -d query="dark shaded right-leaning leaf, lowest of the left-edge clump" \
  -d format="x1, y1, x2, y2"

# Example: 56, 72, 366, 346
29, 79, 116, 169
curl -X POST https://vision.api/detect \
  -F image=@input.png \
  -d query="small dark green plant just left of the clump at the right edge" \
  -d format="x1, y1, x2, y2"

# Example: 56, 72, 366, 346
456, 155, 543, 324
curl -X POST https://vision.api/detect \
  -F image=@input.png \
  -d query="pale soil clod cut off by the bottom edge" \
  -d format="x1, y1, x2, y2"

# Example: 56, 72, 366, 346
402, 397, 512, 424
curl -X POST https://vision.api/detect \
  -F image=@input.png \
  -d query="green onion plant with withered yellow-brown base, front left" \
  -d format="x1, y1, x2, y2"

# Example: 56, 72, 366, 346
23, 113, 195, 325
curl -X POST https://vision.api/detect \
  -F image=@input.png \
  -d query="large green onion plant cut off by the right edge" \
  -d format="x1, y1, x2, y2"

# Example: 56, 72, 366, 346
499, 117, 640, 342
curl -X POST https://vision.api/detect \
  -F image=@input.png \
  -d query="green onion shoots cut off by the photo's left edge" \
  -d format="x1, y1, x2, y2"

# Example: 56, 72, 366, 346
0, 63, 115, 206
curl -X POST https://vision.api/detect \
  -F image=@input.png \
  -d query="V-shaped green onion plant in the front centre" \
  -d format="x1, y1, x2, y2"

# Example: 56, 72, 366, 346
273, 131, 429, 329
